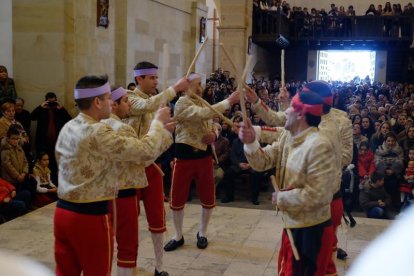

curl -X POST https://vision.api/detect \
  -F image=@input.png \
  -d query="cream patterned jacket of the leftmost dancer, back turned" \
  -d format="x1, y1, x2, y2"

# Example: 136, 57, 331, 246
55, 113, 171, 203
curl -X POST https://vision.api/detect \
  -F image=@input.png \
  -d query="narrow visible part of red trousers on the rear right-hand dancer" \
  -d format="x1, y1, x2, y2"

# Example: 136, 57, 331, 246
326, 197, 344, 275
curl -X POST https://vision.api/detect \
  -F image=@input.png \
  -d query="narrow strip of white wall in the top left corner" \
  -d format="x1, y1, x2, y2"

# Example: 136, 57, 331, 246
0, 0, 13, 77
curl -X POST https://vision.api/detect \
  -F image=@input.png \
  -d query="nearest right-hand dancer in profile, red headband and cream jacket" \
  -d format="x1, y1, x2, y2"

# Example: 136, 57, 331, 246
239, 92, 335, 275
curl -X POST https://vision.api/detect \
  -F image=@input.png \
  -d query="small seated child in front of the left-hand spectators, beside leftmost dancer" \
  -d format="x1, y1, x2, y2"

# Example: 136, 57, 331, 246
32, 152, 57, 208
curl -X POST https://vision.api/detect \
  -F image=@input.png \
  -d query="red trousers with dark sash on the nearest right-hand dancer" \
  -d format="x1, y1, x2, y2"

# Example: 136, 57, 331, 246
278, 220, 334, 276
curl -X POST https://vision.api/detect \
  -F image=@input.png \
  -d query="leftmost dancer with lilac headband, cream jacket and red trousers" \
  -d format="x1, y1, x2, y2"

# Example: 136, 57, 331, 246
54, 76, 171, 276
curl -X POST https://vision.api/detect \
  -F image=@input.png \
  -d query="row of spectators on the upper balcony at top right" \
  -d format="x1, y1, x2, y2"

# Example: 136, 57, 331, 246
253, 0, 414, 37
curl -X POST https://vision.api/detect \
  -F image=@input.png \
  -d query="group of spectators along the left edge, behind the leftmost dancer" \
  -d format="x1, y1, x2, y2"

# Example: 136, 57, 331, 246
0, 66, 71, 223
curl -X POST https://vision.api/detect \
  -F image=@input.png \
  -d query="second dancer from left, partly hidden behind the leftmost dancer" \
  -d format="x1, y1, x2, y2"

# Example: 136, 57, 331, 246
103, 87, 175, 276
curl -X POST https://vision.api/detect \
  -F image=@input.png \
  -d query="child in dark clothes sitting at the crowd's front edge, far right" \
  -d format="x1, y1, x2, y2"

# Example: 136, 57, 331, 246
359, 172, 394, 219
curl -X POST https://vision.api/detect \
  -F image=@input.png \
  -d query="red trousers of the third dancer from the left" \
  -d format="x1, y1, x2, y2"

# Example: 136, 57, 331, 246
137, 165, 167, 233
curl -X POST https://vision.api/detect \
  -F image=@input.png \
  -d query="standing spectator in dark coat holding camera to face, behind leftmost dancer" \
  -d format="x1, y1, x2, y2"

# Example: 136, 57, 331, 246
30, 92, 71, 183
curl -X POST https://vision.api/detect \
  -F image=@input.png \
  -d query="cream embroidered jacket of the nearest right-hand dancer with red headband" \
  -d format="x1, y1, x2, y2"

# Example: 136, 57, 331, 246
244, 127, 336, 228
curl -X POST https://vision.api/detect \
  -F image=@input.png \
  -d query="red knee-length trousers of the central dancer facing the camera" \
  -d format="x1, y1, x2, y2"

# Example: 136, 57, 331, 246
170, 156, 216, 210
